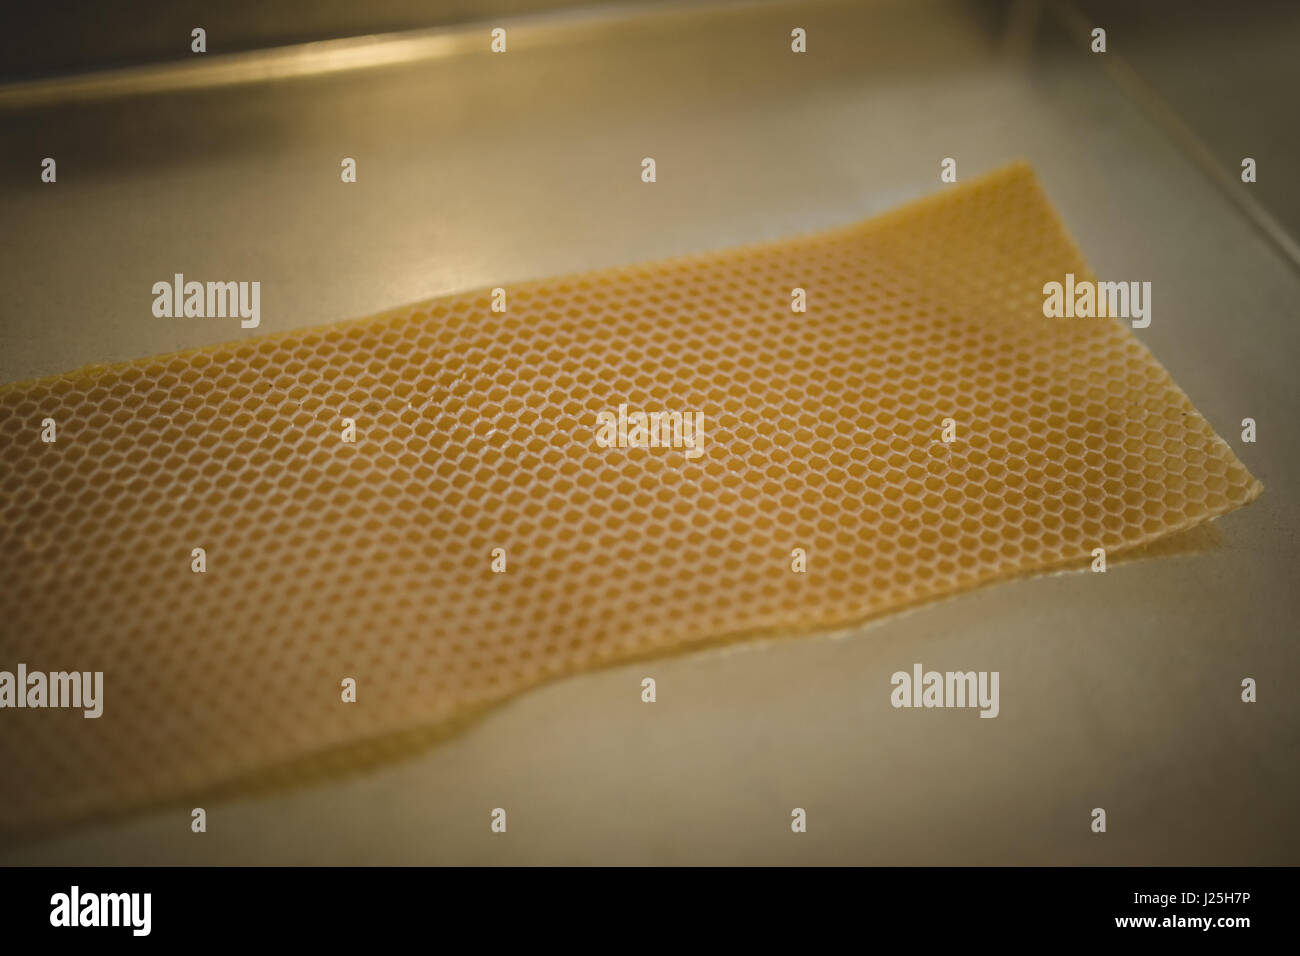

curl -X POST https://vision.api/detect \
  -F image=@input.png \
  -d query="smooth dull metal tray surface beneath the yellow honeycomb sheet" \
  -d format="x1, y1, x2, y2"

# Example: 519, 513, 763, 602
0, 3, 1300, 864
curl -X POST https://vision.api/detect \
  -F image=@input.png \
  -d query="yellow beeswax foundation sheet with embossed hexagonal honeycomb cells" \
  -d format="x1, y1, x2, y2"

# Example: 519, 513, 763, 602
0, 165, 1260, 831
